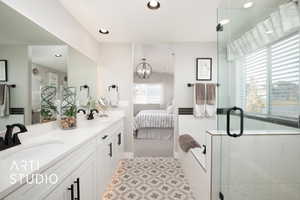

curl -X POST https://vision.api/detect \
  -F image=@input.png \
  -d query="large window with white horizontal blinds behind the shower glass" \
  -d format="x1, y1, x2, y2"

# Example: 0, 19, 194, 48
242, 33, 300, 118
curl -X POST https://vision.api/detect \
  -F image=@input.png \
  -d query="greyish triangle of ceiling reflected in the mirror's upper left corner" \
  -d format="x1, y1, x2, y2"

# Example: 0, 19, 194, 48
0, 1, 63, 45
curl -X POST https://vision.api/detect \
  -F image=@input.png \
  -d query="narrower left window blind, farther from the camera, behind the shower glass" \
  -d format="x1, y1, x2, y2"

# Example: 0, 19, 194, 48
243, 49, 268, 114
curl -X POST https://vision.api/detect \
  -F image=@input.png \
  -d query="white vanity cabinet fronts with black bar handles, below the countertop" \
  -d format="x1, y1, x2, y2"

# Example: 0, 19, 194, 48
0, 117, 123, 200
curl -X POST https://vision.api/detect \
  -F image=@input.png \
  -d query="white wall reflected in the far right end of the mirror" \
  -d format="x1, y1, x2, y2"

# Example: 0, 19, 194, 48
67, 47, 98, 98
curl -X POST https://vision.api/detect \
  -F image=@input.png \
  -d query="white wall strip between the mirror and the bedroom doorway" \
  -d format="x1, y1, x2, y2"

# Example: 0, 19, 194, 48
99, 44, 134, 152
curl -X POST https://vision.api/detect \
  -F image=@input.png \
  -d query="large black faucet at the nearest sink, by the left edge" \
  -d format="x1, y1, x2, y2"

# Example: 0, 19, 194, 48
0, 124, 27, 151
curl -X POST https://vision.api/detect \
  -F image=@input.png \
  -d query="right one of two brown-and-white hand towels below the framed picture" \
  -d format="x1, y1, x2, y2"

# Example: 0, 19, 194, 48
205, 83, 216, 117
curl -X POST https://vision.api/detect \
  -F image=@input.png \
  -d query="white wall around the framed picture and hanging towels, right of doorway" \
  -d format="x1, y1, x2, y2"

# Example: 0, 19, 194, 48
174, 43, 218, 151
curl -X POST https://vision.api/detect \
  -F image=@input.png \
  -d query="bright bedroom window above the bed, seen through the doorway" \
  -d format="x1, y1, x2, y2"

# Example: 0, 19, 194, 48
134, 84, 162, 104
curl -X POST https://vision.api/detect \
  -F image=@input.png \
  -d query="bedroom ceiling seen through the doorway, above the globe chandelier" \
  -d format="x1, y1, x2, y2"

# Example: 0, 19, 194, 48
134, 44, 174, 74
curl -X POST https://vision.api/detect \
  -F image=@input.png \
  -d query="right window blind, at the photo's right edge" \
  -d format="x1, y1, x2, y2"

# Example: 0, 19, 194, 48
270, 34, 300, 117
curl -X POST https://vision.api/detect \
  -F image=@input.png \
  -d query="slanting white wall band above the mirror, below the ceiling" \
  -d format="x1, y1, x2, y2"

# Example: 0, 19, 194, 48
1, 0, 99, 61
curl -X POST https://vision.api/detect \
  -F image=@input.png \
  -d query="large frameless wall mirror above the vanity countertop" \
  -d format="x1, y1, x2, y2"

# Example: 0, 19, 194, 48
0, 3, 97, 132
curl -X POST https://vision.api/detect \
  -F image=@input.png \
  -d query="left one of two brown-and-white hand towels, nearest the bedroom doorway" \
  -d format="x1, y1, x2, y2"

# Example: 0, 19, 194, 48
194, 83, 205, 118
